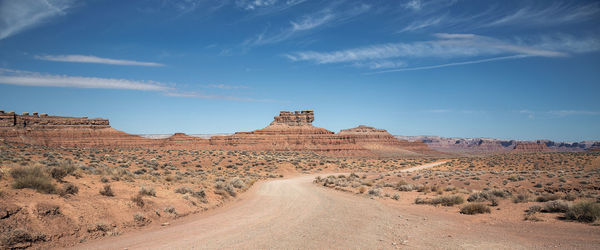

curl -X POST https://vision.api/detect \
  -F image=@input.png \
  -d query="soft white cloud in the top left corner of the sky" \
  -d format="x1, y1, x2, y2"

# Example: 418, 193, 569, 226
0, 0, 73, 40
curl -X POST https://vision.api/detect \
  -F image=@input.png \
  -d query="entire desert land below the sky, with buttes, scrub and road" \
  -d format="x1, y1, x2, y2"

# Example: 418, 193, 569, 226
0, 111, 600, 249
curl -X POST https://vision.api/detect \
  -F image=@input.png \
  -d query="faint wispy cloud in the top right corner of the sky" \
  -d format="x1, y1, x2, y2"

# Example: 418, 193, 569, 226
484, 1, 600, 26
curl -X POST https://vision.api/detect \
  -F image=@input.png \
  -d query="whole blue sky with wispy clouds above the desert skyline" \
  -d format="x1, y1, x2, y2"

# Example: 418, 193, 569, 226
0, 0, 600, 141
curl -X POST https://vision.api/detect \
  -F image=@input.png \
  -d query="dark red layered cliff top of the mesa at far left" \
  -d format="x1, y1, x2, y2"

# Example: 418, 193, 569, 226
0, 110, 110, 129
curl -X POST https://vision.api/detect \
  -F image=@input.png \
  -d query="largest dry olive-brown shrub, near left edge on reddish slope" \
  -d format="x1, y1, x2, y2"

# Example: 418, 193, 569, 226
10, 167, 56, 194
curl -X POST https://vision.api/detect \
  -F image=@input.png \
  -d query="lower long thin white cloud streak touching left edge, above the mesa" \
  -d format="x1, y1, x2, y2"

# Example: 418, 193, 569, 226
0, 68, 172, 91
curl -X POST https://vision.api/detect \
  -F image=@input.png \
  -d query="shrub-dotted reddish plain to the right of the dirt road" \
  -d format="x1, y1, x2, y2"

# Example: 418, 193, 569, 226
314, 153, 600, 225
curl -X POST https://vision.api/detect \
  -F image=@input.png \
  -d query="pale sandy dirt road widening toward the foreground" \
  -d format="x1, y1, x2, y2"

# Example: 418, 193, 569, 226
76, 163, 600, 249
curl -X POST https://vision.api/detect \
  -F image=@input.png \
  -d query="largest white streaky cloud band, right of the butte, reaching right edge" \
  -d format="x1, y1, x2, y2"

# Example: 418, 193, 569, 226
284, 33, 600, 73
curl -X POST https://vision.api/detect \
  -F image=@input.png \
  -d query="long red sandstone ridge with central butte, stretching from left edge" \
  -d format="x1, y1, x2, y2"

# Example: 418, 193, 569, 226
0, 110, 440, 157
